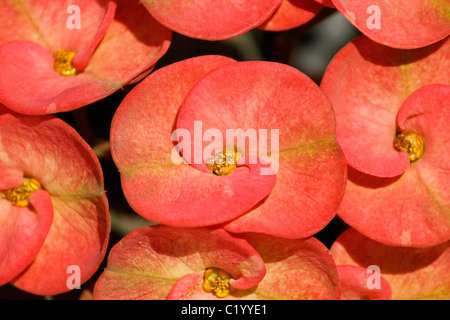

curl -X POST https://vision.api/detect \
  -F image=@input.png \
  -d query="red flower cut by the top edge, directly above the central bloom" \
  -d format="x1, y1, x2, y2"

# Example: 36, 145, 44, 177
143, 0, 322, 40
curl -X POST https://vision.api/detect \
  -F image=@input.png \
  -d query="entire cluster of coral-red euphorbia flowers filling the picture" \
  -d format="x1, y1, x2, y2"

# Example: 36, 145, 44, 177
0, 0, 450, 300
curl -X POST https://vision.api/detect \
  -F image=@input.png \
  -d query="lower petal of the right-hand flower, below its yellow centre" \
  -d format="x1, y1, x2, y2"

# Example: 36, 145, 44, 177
338, 163, 450, 247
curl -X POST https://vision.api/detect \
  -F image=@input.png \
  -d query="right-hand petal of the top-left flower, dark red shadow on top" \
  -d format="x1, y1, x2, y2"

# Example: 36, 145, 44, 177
86, 0, 172, 84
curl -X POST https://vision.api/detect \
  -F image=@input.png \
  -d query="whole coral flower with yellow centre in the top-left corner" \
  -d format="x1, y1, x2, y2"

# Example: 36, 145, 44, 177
0, 0, 171, 115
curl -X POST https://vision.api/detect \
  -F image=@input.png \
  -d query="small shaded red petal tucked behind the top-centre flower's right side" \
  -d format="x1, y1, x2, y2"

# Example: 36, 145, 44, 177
258, 0, 323, 31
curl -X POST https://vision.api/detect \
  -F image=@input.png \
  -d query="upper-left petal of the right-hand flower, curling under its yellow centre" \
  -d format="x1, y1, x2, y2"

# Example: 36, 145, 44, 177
321, 35, 450, 177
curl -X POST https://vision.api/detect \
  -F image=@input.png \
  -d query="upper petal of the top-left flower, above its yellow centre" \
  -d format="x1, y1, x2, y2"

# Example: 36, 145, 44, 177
0, 0, 116, 52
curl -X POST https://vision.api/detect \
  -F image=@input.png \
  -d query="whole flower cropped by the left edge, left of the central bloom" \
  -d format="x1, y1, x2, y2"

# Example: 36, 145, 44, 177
0, 106, 110, 295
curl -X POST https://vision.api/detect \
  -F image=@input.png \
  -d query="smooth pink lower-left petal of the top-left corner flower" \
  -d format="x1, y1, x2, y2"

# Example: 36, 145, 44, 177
0, 40, 121, 115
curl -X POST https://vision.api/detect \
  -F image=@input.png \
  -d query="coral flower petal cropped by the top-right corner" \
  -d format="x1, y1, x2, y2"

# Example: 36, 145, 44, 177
333, 0, 450, 49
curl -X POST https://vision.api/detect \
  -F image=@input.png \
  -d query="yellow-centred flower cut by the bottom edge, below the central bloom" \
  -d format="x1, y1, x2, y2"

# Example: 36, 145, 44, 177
94, 225, 340, 300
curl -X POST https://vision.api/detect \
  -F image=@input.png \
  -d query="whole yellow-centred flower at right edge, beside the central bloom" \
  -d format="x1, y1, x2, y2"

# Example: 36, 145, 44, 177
321, 35, 450, 247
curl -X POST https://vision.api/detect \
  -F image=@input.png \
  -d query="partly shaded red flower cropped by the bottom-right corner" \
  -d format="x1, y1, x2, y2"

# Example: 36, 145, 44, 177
330, 229, 450, 300
